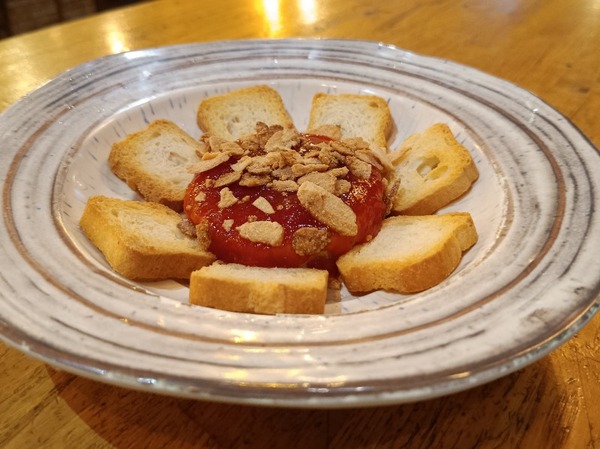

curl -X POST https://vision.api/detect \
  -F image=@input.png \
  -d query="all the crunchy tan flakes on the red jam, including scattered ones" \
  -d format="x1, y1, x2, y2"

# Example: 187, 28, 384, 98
190, 122, 399, 245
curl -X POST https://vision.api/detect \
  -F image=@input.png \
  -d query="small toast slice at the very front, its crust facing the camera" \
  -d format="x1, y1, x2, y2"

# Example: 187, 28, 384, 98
190, 263, 328, 314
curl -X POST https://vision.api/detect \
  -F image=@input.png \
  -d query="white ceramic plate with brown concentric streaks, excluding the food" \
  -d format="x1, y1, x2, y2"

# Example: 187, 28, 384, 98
0, 40, 600, 407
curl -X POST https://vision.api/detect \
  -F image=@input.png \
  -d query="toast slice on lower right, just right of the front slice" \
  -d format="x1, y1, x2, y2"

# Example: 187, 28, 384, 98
337, 213, 477, 293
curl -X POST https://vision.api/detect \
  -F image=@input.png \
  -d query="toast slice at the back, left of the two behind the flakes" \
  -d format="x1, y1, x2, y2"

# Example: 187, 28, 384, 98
197, 85, 294, 141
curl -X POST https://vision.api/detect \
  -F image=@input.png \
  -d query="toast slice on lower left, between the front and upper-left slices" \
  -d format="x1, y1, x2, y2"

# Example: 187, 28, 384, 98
80, 196, 215, 280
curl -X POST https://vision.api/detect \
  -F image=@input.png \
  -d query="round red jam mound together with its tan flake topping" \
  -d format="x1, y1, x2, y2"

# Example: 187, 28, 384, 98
184, 123, 395, 269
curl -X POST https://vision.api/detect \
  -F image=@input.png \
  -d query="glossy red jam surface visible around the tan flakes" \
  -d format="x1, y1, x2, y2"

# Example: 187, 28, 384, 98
184, 136, 386, 269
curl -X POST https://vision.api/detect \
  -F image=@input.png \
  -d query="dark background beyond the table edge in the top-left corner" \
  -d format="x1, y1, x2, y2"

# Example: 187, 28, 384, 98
0, 0, 138, 39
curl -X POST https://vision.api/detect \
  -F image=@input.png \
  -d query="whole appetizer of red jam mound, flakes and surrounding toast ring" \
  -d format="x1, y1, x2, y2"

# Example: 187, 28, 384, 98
80, 85, 479, 314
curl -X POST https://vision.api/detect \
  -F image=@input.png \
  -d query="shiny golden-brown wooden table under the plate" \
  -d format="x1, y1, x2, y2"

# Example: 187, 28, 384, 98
0, 0, 600, 449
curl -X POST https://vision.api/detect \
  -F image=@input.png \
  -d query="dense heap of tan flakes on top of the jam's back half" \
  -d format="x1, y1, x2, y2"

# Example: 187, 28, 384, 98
191, 122, 394, 194
